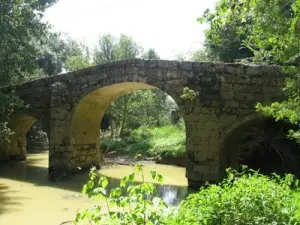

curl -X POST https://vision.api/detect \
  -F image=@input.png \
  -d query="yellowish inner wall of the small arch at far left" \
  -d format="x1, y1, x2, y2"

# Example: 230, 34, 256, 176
0, 114, 37, 160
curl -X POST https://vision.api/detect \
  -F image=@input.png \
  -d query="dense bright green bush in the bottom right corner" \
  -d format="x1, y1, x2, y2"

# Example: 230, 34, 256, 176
168, 168, 300, 225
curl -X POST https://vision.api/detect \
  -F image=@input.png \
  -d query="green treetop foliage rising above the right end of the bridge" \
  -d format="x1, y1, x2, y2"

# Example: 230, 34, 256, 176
198, 0, 300, 65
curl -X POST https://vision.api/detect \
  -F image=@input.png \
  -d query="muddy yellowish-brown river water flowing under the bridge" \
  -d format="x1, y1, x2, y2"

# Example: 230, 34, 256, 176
0, 152, 188, 225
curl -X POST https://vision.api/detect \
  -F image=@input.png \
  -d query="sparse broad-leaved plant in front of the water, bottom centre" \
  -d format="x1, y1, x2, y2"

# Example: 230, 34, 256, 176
75, 164, 168, 225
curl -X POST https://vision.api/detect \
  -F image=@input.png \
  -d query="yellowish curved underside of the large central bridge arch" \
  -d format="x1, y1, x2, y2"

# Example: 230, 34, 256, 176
69, 77, 184, 168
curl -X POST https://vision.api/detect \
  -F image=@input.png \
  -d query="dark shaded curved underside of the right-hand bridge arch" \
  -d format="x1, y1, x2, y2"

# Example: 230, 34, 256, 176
220, 114, 265, 175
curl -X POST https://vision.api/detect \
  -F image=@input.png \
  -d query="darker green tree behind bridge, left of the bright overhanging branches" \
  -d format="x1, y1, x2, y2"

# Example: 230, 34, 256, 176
198, 0, 253, 62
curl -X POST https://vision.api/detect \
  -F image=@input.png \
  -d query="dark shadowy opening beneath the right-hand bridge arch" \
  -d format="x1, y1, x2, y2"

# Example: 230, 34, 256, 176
221, 118, 300, 175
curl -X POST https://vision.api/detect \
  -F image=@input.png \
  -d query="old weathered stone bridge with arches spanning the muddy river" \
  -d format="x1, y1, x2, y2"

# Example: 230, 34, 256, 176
0, 59, 284, 186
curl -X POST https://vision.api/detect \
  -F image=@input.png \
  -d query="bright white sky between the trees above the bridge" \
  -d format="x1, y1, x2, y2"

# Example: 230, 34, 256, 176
44, 0, 217, 59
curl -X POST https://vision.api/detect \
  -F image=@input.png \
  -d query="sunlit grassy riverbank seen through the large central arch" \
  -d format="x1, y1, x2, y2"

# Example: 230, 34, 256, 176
100, 124, 186, 166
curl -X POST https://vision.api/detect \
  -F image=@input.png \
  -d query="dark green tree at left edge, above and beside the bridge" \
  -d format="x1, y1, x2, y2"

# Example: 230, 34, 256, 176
0, 0, 56, 142
